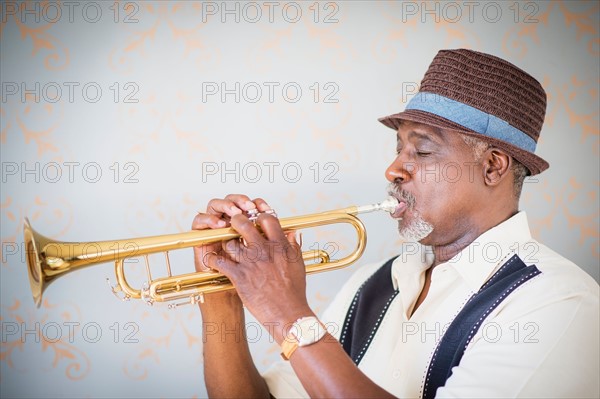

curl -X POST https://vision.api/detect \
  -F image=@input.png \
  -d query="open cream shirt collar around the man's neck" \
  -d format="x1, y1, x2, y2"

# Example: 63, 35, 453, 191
391, 212, 532, 296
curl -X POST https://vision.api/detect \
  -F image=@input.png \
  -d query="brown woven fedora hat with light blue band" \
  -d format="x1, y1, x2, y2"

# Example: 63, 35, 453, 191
379, 49, 549, 175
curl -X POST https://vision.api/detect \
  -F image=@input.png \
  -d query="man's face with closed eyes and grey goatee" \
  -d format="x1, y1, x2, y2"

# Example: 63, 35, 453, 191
385, 121, 484, 245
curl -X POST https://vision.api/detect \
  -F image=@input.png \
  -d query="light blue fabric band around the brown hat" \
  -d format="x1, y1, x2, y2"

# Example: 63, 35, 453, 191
405, 92, 536, 152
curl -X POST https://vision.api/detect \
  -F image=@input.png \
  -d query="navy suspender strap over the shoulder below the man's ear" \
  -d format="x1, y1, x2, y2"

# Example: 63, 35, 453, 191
423, 255, 541, 399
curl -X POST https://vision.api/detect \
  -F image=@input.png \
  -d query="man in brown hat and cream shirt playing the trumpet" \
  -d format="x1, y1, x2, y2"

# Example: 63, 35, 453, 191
193, 49, 599, 398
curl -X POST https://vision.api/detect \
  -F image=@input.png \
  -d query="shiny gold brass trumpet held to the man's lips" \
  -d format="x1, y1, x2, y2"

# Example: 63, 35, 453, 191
23, 197, 398, 307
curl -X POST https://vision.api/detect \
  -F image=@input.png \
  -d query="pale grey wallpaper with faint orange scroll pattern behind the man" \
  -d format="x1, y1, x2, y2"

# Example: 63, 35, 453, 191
0, 1, 600, 398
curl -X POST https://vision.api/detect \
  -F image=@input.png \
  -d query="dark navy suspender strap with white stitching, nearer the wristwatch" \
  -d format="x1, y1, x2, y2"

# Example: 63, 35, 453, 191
340, 257, 398, 364
